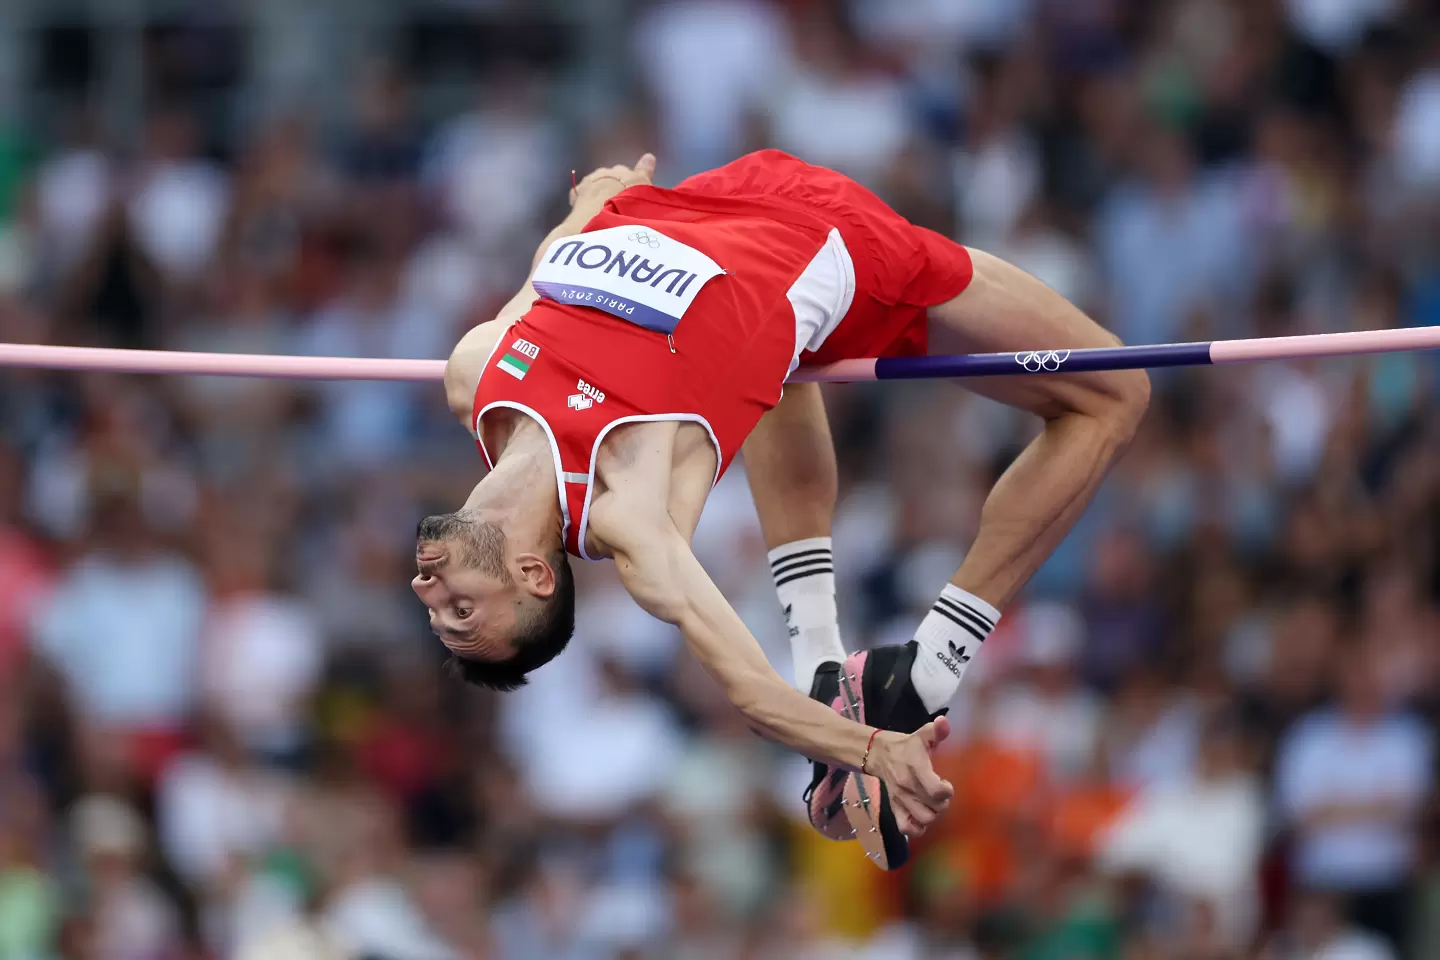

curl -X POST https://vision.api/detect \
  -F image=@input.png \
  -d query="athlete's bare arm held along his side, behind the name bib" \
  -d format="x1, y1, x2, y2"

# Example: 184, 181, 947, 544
445, 154, 655, 430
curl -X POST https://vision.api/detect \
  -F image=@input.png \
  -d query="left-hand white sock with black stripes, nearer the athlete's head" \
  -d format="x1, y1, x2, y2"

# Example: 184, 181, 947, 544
770, 537, 845, 694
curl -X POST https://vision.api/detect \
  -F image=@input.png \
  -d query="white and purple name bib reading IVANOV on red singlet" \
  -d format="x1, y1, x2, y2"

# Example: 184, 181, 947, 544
531, 223, 724, 334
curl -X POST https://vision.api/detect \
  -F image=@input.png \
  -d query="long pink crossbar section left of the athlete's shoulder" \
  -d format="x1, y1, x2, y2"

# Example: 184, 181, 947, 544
0, 344, 445, 381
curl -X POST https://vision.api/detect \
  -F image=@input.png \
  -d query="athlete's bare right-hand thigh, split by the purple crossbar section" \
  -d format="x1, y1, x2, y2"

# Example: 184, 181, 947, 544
930, 248, 1149, 417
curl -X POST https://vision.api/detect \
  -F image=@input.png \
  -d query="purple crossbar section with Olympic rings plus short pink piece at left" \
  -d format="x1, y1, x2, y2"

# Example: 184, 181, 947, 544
791, 344, 1210, 383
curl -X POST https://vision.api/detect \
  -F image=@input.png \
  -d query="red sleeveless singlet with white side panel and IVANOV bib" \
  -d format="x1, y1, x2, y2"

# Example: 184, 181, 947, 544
472, 179, 848, 556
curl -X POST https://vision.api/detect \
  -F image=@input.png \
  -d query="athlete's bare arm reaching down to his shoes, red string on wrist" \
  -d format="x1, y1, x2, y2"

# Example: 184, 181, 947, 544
590, 492, 953, 828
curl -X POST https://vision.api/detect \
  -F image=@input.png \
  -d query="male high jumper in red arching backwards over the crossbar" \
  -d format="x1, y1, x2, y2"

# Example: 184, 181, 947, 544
413, 150, 1149, 869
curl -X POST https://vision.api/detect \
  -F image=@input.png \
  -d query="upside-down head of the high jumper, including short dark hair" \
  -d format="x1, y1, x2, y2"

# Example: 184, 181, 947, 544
410, 511, 575, 691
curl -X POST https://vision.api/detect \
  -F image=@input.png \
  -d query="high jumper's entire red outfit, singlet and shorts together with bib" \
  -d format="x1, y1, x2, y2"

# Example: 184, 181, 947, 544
474, 150, 971, 557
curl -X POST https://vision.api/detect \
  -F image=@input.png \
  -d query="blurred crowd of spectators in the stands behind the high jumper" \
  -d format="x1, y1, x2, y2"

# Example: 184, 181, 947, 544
0, 0, 1440, 960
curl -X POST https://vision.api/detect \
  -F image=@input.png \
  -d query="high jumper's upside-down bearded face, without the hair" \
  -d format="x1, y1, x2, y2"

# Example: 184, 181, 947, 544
410, 514, 521, 661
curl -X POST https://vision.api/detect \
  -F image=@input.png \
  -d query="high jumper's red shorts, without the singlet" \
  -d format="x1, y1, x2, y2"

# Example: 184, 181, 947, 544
675, 150, 975, 363
